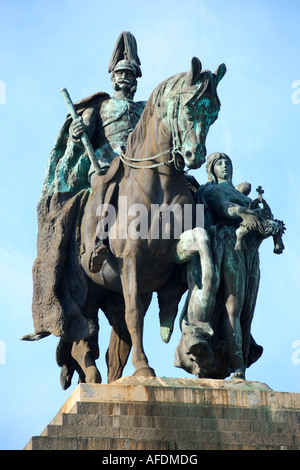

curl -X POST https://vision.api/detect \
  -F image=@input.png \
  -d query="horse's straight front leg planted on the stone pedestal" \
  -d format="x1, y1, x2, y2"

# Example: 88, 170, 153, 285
121, 256, 155, 377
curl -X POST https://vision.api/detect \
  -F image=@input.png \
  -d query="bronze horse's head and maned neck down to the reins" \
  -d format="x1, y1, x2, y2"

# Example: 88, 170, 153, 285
123, 57, 226, 172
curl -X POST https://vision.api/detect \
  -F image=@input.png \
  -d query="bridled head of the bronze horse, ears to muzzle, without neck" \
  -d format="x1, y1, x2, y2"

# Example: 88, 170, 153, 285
169, 57, 226, 168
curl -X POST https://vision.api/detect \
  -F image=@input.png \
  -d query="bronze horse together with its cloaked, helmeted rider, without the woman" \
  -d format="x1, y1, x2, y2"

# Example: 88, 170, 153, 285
23, 32, 226, 389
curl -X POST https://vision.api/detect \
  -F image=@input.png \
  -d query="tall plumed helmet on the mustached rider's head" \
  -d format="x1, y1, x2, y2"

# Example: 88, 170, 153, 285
108, 31, 142, 78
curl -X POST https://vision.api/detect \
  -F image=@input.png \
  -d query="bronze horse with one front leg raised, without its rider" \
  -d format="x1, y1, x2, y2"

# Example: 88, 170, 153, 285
71, 58, 226, 382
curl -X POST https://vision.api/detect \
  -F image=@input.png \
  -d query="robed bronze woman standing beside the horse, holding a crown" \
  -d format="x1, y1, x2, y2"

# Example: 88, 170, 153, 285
175, 153, 265, 379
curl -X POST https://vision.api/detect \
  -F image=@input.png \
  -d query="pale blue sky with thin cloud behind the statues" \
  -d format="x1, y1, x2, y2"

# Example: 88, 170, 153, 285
0, 0, 300, 449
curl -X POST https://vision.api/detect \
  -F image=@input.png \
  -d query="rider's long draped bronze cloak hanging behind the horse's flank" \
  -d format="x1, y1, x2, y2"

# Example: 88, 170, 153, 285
32, 93, 109, 342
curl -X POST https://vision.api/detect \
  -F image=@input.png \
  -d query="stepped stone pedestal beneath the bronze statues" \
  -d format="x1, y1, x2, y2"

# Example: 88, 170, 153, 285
25, 377, 300, 451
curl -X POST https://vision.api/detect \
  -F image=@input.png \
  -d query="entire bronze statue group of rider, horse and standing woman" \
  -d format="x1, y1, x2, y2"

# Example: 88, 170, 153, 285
24, 28, 284, 389
